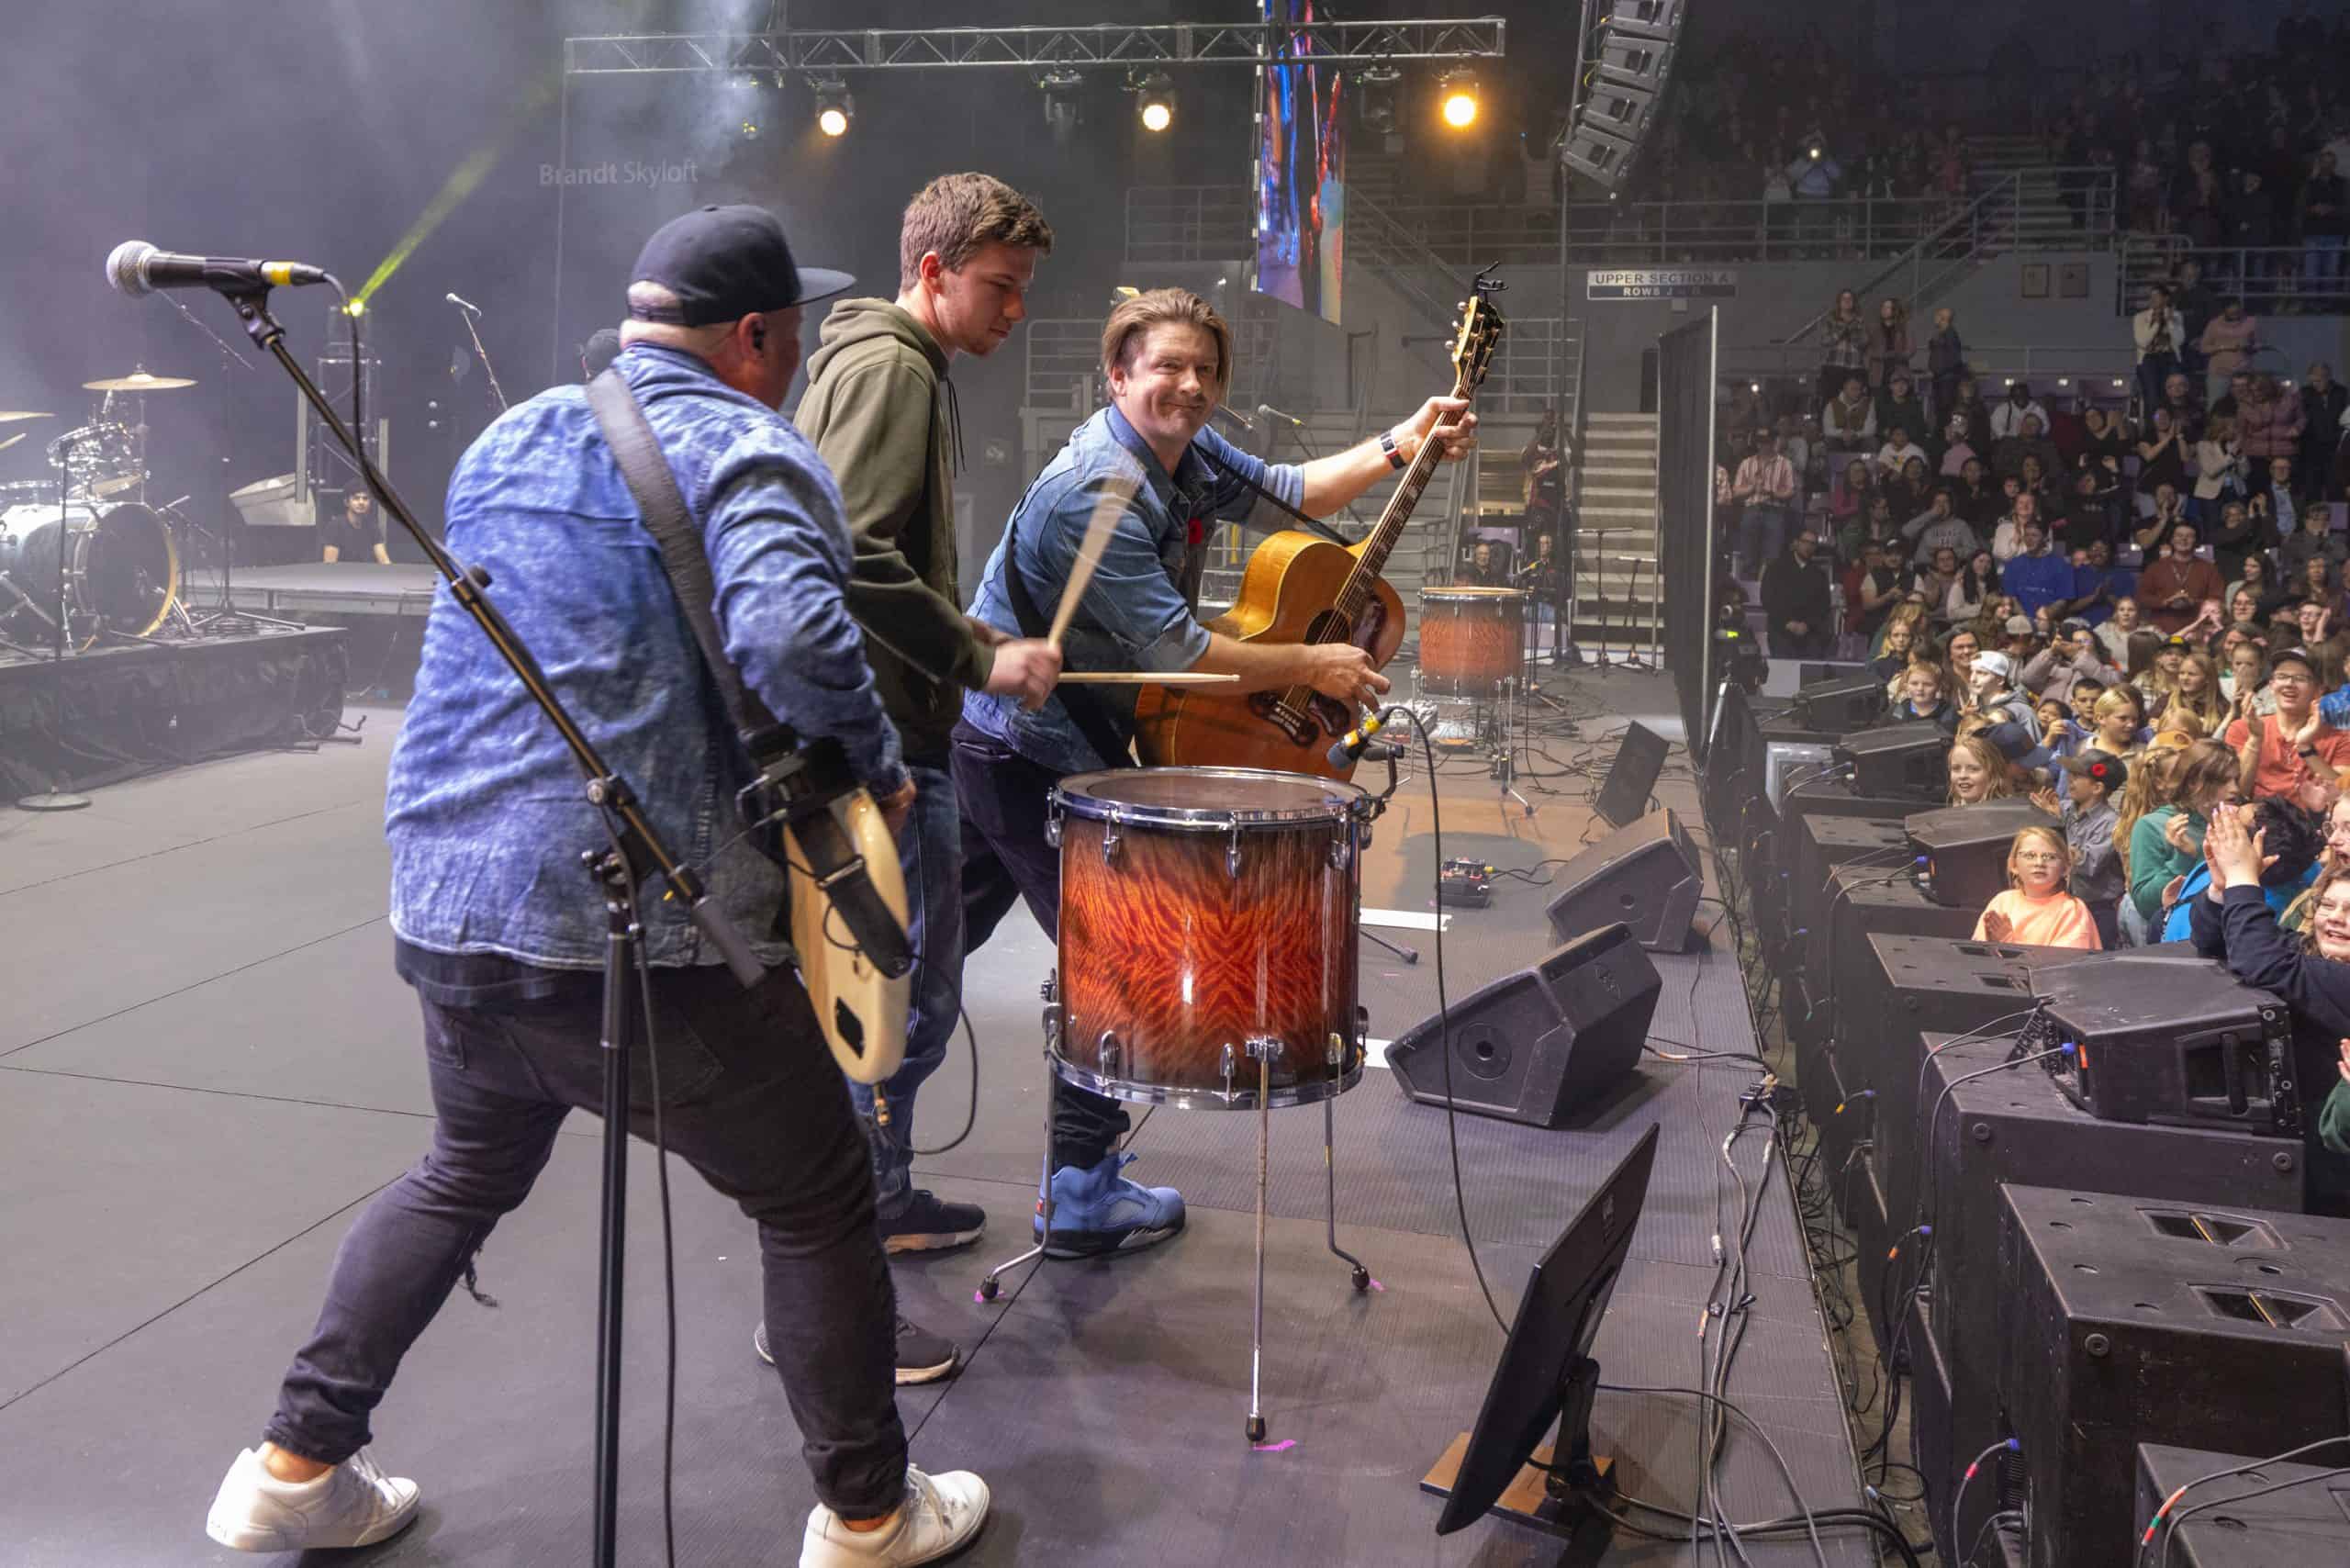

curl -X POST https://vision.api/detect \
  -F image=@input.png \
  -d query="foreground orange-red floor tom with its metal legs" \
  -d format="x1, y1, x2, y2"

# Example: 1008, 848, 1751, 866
980, 764, 1396, 1443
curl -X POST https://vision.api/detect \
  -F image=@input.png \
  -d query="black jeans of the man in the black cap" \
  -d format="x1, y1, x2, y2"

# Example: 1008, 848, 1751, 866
263, 969, 905, 1518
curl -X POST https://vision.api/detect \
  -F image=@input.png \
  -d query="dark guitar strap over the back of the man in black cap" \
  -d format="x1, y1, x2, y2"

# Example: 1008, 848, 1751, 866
588, 369, 912, 976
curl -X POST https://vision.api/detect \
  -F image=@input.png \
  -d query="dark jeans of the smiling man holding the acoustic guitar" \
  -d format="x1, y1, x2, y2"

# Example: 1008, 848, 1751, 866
954, 724, 1133, 1170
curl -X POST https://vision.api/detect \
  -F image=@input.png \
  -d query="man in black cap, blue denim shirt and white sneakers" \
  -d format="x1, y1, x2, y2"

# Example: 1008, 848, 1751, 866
207, 207, 990, 1563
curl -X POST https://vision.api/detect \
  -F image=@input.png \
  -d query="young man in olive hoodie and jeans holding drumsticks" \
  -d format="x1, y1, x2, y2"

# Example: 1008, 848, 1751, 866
794, 174, 1060, 1383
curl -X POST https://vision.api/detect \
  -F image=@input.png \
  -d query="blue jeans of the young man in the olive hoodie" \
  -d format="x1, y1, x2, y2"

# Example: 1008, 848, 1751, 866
848, 762, 964, 1223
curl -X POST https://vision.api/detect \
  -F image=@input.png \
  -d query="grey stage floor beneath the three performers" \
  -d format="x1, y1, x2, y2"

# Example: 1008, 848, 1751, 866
0, 675, 1875, 1568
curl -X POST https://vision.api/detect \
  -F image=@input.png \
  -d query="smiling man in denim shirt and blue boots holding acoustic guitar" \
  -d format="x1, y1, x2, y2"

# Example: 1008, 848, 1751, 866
952, 289, 1476, 1258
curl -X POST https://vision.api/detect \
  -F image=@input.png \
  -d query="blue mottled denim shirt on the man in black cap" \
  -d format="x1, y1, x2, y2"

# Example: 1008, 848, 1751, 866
386, 343, 905, 969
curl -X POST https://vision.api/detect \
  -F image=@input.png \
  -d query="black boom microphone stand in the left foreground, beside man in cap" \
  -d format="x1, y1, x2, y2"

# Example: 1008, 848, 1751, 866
214, 277, 767, 1568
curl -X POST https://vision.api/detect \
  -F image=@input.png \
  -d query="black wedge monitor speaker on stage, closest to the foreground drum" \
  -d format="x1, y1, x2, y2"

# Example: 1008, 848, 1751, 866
1386, 926, 1663, 1126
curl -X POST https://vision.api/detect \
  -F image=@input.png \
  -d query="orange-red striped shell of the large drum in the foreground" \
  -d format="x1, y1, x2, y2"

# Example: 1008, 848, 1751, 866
1060, 816, 1363, 1110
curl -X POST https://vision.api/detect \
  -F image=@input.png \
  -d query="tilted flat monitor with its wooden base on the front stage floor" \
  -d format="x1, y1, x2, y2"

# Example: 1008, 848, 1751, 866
1419, 1126, 1659, 1538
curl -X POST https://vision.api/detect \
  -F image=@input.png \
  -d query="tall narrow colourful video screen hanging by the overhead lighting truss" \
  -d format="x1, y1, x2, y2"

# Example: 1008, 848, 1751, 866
1255, 0, 1347, 327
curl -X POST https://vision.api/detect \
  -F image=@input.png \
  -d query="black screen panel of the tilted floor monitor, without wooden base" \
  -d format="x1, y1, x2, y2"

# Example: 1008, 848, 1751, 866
1436, 1126, 1659, 1535
